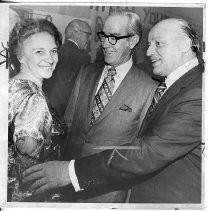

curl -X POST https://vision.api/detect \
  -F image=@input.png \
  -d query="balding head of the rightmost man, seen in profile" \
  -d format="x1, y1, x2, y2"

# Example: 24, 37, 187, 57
147, 18, 198, 76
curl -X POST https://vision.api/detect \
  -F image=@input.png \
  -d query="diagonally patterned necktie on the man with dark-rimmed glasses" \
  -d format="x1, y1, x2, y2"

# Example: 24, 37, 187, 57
90, 67, 117, 126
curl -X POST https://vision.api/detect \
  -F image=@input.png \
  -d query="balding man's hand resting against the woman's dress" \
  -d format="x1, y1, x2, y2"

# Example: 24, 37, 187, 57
23, 161, 71, 194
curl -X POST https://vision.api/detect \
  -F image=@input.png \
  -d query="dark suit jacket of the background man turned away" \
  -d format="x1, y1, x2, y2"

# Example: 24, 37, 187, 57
43, 40, 91, 117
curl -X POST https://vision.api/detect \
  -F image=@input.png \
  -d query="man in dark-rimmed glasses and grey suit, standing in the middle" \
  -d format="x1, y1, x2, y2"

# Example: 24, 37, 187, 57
23, 11, 156, 203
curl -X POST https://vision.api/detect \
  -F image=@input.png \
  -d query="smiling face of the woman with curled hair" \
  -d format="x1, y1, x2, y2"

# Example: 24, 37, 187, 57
20, 32, 58, 80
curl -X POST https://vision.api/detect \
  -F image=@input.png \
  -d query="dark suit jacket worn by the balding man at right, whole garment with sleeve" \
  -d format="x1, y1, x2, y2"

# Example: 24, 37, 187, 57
75, 62, 203, 203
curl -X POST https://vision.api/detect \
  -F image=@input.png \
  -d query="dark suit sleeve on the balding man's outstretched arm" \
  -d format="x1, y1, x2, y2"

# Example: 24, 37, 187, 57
75, 85, 202, 190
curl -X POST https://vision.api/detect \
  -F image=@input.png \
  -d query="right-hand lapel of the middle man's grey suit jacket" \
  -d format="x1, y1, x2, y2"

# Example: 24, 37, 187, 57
96, 66, 140, 123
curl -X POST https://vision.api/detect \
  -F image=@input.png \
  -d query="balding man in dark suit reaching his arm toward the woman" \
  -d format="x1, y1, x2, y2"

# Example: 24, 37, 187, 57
24, 19, 203, 203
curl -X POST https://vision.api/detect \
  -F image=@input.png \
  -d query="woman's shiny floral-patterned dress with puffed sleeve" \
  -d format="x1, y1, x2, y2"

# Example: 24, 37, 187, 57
8, 79, 65, 201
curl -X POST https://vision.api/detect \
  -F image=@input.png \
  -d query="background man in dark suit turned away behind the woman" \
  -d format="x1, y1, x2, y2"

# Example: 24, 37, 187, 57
43, 19, 92, 117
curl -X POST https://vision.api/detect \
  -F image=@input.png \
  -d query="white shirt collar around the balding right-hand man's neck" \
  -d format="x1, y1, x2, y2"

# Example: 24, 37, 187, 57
165, 57, 199, 88
